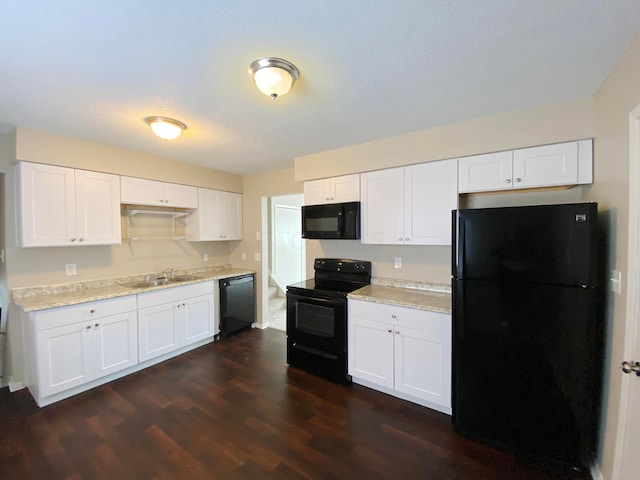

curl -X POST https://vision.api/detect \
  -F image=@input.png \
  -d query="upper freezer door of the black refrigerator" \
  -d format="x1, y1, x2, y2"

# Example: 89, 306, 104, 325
452, 203, 598, 286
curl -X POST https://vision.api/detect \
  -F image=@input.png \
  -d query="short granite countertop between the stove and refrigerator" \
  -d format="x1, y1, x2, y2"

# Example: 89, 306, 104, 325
348, 278, 451, 314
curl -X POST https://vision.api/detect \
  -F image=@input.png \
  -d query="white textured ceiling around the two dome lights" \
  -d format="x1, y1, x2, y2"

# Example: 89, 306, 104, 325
0, 0, 640, 175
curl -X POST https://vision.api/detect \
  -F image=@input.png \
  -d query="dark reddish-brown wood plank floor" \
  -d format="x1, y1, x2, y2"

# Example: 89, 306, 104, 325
0, 330, 589, 480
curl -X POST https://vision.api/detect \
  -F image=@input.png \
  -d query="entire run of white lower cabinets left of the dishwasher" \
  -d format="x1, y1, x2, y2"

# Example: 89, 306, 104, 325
24, 281, 216, 406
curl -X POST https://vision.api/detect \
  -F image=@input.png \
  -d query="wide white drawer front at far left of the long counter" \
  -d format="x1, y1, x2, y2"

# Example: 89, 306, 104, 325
31, 295, 136, 331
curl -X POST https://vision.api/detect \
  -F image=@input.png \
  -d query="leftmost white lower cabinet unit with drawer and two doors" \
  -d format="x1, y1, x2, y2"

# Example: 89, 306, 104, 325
27, 295, 138, 405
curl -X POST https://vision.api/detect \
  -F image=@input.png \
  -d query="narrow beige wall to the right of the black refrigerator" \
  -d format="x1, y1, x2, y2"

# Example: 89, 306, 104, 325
587, 31, 640, 480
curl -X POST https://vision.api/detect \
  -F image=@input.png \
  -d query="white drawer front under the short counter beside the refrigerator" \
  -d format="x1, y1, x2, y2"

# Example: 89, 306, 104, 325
349, 300, 451, 335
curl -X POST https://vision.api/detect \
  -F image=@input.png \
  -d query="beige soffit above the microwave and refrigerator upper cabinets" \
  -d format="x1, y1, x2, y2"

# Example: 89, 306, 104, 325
295, 98, 595, 181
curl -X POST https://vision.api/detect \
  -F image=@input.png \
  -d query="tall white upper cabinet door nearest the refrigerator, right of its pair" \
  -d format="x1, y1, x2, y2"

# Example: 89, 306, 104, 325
404, 160, 458, 245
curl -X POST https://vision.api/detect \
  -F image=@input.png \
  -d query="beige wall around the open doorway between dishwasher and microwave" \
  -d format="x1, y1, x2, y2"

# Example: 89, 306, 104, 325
231, 168, 303, 326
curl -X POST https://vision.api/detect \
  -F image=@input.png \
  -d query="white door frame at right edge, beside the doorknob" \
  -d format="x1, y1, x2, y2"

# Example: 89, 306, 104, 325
613, 105, 640, 478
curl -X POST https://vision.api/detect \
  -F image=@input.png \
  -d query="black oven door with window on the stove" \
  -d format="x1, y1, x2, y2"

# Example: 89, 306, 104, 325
287, 292, 347, 354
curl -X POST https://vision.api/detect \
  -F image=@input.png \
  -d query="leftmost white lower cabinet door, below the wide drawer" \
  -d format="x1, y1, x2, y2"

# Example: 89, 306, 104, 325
36, 323, 92, 397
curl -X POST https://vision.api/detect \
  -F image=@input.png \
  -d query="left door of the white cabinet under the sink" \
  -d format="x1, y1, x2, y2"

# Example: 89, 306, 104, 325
138, 303, 180, 362
